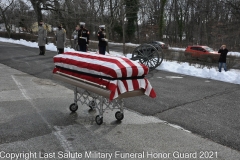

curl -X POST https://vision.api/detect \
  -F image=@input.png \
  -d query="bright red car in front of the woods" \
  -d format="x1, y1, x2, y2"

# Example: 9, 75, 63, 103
184, 45, 220, 62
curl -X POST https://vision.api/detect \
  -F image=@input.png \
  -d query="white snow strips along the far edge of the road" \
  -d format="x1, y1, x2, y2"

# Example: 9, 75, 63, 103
0, 38, 240, 84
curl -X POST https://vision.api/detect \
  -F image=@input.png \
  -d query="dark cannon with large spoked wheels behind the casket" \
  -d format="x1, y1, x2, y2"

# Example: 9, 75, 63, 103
131, 44, 163, 71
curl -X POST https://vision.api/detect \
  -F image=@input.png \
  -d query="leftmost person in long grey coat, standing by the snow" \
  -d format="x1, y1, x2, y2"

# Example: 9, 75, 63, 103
38, 20, 47, 55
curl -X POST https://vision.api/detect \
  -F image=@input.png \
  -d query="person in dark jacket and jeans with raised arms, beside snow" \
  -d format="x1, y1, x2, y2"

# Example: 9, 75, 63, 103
218, 45, 228, 72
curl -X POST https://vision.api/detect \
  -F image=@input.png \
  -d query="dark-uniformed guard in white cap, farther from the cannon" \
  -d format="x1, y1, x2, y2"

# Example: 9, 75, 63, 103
78, 22, 89, 52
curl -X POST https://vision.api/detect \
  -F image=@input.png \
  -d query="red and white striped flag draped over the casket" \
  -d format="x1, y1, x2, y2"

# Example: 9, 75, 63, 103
53, 52, 156, 100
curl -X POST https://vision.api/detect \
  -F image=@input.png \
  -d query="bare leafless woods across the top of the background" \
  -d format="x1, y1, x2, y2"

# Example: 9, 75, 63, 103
0, 0, 240, 50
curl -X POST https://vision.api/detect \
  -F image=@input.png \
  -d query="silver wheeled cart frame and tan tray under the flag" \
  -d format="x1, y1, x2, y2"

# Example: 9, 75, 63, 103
54, 71, 144, 125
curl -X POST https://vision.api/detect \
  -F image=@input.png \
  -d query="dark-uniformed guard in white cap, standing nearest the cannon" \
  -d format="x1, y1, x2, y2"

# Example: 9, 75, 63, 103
98, 25, 108, 55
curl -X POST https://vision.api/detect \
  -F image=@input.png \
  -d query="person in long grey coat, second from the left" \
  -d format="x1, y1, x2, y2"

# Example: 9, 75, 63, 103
55, 24, 66, 54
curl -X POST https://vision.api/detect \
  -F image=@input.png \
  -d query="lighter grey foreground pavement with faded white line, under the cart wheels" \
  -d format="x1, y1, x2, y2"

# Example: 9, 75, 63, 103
0, 64, 240, 160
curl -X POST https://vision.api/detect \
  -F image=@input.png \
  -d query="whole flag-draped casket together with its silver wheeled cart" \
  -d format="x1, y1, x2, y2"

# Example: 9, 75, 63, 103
53, 52, 156, 125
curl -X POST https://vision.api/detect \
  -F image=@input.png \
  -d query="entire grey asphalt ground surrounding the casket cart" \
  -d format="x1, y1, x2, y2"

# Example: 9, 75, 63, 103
0, 42, 240, 159
